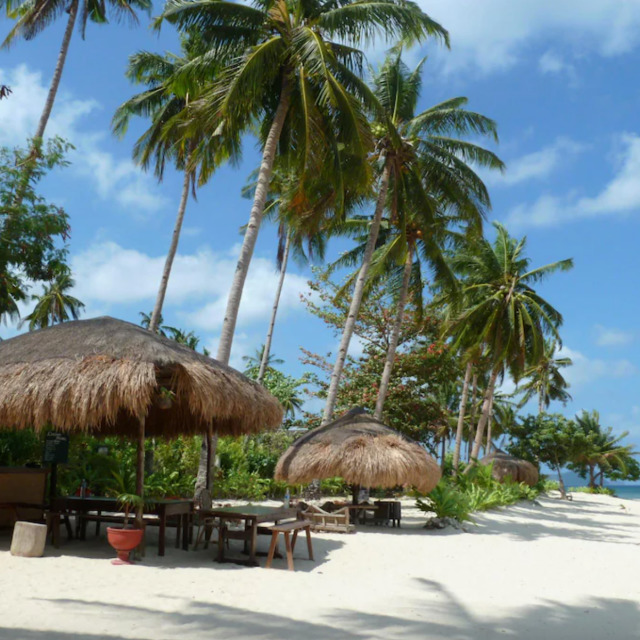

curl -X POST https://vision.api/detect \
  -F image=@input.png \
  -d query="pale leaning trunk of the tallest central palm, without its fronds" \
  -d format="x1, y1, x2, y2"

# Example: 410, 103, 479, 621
217, 76, 291, 364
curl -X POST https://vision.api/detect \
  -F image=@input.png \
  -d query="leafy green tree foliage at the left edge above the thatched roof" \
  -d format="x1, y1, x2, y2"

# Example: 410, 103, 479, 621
0, 138, 71, 322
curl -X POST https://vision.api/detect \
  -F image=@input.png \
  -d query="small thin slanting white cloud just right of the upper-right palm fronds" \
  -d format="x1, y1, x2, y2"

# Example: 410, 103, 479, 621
486, 137, 587, 186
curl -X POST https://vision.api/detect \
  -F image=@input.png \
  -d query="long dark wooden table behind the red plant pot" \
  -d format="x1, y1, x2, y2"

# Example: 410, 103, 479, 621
53, 496, 193, 556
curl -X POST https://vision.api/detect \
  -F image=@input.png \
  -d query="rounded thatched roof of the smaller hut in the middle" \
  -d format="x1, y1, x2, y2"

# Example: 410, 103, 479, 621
275, 409, 440, 493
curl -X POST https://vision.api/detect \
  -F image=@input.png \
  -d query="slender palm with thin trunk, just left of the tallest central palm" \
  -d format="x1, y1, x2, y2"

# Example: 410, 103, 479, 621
112, 43, 234, 332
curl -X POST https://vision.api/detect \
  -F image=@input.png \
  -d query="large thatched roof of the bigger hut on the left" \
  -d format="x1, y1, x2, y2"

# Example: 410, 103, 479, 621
0, 317, 282, 436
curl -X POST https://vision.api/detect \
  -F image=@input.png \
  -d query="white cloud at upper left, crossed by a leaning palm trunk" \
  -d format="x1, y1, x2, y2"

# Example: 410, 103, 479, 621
0, 65, 166, 213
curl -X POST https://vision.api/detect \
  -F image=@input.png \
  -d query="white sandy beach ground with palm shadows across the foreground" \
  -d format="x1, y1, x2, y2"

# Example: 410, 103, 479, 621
0, 494, 640, 640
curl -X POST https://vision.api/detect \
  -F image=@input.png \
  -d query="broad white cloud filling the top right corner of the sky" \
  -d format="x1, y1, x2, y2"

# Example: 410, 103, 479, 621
419, 0, 640, 73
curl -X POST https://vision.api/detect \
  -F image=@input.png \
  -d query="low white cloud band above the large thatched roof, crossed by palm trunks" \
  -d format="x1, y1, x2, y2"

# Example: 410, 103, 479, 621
72, 242, 308, 331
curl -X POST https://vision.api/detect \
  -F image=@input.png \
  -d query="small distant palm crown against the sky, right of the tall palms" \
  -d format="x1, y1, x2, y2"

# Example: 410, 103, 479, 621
520, 340, 573, 413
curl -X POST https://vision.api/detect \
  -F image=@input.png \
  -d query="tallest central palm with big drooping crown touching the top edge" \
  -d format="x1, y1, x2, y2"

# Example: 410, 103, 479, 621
157, 0, 448, 364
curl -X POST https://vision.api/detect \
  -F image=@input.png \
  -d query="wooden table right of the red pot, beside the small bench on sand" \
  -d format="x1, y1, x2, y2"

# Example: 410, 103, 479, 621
207, 505, 298, 566
